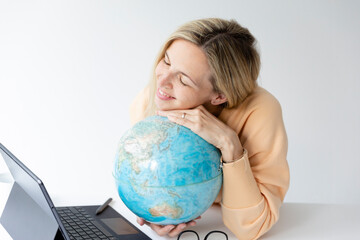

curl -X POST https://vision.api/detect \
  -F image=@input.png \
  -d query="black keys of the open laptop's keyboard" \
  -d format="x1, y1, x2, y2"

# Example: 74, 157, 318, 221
56, 207, 116, 240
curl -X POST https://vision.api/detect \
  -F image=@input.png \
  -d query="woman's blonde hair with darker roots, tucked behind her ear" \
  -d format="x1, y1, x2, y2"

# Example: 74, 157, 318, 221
144, 18, 260, 116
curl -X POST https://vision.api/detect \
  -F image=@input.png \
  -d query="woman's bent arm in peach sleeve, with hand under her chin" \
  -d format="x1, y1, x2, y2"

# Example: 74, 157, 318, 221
159, 91, 289, 239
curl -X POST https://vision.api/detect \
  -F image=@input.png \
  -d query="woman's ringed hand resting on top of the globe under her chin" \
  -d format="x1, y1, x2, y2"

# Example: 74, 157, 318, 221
157, 105, 243, 162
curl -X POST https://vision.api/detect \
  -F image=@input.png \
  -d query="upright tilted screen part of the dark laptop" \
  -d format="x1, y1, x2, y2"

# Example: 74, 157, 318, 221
0, 144, 59, 239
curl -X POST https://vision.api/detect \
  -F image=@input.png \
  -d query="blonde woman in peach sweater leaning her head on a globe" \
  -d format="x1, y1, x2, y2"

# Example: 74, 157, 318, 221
130, 18, 289, 239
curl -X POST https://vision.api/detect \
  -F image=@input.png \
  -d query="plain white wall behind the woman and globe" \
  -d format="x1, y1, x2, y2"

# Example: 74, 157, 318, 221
0, 0, 360, 203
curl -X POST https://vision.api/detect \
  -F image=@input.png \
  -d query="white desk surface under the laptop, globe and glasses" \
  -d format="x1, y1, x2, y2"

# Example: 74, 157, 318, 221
0, 183, 360, 240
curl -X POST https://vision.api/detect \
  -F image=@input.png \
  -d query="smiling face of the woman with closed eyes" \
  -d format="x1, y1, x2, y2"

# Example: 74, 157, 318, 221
155, 39, 218, 110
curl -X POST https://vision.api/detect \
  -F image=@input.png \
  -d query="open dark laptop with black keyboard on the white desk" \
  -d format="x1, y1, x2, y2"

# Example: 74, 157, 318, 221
0, 143, 150, 240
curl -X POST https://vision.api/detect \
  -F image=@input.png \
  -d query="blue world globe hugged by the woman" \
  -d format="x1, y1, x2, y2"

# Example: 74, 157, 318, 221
113, 116, 222, 225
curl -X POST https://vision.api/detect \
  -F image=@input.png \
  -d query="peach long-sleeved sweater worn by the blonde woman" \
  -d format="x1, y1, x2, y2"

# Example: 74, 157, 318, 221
130, 87, 289, 239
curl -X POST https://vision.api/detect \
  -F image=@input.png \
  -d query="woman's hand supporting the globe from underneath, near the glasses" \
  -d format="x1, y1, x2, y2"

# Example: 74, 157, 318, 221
136, 216, 201, 237
